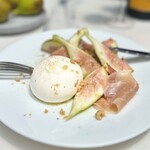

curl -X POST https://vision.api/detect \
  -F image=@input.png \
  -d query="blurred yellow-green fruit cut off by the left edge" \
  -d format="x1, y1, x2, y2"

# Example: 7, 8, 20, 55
0, 0, 10, 23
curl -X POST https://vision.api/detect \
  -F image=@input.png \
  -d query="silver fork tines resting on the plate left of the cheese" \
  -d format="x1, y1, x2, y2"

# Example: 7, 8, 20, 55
0, 61, 33, 79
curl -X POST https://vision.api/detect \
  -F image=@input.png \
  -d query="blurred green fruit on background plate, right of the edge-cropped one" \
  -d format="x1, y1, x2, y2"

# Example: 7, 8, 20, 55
13, 0, 43, 15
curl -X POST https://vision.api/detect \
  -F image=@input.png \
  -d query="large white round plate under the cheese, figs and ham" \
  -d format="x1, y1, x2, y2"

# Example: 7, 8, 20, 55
0, 29, 150, 148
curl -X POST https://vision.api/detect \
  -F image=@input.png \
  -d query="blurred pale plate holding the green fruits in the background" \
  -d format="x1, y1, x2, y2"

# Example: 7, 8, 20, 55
0, 11, 46, 35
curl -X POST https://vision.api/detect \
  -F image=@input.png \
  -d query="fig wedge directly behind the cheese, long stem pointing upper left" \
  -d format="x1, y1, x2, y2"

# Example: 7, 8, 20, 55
53, 35, 100, 77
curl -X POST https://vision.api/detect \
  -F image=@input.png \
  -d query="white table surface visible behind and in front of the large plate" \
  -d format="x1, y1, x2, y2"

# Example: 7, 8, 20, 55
0, 0, 150, 150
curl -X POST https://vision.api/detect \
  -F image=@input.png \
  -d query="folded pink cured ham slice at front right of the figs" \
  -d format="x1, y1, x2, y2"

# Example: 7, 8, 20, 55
95, 72, 139, 112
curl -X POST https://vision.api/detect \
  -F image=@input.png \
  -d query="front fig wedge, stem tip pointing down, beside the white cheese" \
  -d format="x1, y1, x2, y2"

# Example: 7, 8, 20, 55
66, 67, 108, 120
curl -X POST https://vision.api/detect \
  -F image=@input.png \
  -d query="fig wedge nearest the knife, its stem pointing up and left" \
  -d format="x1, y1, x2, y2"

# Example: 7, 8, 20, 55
86, 34, 133, 73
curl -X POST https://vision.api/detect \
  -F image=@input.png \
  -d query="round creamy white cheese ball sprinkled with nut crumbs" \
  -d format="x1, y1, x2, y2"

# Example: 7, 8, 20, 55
30, 56, 83, 103
